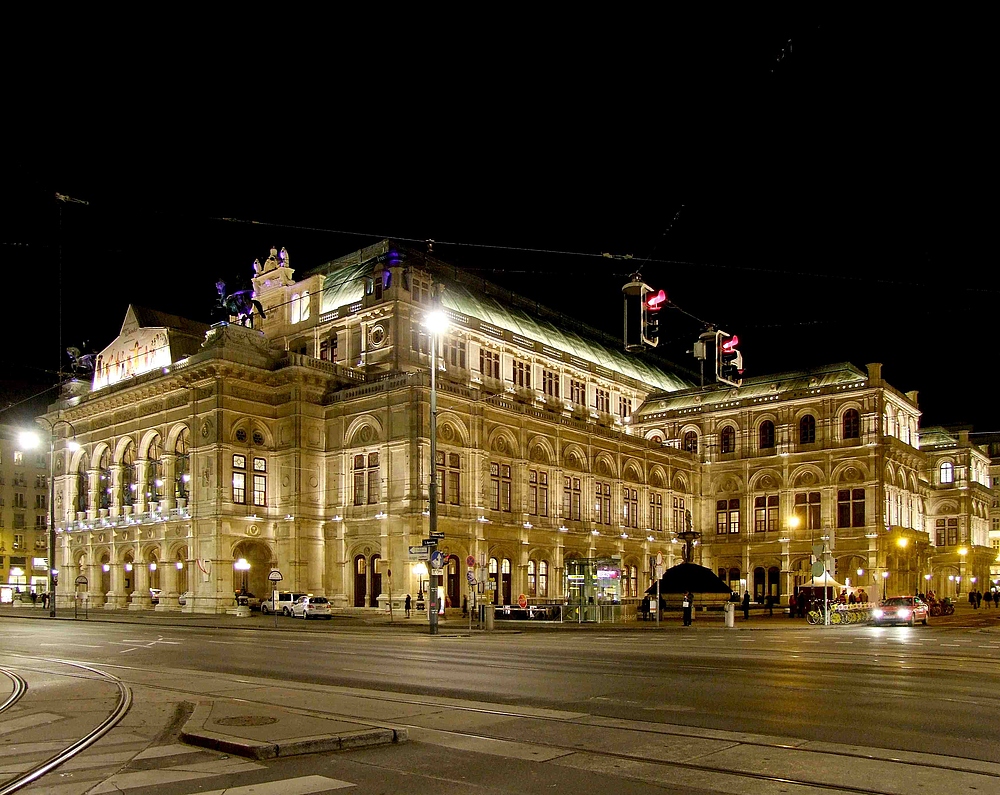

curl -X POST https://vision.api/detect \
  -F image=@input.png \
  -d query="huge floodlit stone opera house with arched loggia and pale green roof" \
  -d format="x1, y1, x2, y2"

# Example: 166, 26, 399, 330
33, 241, 1000, 612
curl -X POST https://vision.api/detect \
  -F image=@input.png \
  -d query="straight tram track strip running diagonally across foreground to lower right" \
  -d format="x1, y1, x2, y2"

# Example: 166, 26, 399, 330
11, 666, 1000, 795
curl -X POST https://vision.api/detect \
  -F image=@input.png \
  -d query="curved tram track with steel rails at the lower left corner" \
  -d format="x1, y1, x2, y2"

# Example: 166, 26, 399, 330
0, 655, 132, 795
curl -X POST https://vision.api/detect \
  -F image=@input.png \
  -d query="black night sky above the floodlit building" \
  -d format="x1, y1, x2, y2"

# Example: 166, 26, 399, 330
0, 9, 1000, 431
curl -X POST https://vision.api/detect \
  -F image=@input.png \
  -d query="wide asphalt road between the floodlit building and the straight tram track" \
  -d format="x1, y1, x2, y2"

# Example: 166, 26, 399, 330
0, 610, 1000, 793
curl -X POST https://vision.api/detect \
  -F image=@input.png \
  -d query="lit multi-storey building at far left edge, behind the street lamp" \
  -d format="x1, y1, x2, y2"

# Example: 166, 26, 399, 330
0, 425, 49, 601
